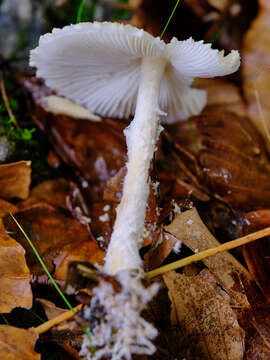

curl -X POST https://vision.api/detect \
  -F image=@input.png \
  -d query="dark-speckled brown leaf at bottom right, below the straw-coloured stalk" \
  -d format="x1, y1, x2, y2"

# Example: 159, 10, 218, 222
163, 272, 244, 360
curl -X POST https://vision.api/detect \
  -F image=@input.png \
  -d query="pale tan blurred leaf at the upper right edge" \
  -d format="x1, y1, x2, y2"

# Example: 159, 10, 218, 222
242, 0, 270, 141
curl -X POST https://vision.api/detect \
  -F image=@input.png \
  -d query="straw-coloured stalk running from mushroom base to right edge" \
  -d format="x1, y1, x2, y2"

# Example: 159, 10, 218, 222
147, 227, 270, 278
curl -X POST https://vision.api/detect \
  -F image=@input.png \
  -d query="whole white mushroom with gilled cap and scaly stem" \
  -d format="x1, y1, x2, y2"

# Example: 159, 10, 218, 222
30, 22, 240, 274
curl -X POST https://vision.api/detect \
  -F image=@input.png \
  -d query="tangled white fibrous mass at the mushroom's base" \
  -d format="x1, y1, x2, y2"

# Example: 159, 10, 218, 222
80, 270, 159, 360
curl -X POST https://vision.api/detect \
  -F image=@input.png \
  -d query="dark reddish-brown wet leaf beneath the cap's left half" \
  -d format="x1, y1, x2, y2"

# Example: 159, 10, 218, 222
21, 77, 127, 201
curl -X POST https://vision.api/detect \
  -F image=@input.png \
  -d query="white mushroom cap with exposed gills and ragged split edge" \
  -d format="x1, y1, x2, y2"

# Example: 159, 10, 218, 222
30, 22, 240, 122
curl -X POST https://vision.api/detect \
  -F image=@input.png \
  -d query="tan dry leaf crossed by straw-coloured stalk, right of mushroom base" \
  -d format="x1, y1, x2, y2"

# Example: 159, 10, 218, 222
165, 208, 249, 306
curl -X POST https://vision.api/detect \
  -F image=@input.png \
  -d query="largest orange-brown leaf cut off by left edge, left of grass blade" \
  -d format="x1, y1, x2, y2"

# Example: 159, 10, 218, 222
0, 200, 33, 313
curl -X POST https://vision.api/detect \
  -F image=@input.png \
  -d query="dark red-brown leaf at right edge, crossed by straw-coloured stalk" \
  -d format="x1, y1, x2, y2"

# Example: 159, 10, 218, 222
242, 210, 270, 301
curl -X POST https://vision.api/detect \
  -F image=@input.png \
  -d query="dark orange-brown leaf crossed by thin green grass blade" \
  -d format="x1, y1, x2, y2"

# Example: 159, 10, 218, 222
4, 203, 104, 280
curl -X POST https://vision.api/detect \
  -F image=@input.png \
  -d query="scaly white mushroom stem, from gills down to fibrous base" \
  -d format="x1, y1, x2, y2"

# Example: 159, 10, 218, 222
105, 57, 166, 274
